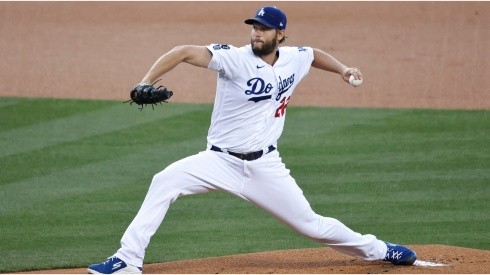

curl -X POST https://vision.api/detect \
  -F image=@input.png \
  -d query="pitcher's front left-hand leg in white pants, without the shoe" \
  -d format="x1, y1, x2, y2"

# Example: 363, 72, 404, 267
115, 151, 245, 267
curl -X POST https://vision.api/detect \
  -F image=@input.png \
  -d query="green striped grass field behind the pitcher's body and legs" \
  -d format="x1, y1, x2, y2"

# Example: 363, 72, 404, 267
0, 98, 490, 273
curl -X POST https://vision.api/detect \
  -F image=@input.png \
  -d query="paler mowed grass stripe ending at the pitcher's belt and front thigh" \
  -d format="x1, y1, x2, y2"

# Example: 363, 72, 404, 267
0, 138, 205, 217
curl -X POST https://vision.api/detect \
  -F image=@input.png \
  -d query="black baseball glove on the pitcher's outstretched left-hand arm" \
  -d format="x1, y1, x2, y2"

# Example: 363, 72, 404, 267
126, 82, 174, 110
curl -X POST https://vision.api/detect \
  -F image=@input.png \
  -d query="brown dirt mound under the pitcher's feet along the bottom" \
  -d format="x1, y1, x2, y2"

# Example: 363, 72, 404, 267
22, 245, 490, 274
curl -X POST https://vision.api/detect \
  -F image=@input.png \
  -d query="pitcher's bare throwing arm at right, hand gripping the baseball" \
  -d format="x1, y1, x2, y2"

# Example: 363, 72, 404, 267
311, 49, 362, 83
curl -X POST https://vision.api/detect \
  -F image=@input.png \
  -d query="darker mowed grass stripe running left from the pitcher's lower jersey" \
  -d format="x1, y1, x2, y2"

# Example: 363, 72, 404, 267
0, 107, 210, 185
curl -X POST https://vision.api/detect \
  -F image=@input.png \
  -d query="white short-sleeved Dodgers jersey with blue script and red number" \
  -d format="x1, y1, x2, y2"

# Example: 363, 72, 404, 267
208, 44, 313, 152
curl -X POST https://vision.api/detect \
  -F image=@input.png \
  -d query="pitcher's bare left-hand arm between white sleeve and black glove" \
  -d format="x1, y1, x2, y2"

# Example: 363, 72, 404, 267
141, 45, 213, 83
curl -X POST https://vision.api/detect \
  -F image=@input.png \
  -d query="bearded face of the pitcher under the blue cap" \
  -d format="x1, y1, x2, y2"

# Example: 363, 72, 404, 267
250, 23, 279, 56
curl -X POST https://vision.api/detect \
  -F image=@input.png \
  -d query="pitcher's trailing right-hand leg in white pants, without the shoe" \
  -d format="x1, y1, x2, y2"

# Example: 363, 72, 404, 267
242, 152, 387, 260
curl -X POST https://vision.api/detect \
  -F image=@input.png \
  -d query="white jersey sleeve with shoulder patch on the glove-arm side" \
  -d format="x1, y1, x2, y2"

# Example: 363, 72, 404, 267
207, 44, 240, 79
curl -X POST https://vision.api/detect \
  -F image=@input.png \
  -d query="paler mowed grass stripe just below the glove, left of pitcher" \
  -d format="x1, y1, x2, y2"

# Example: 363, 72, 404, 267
0, 101, 209, 158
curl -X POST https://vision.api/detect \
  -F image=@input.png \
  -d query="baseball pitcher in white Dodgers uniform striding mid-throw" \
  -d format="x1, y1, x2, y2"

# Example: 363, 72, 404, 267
88, 6, 416, 274
